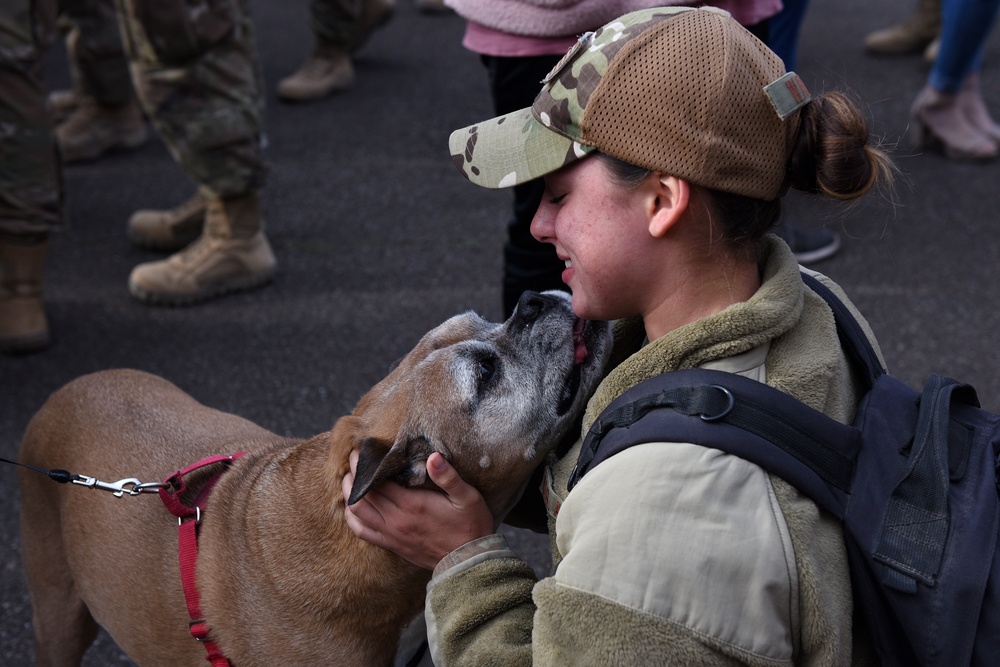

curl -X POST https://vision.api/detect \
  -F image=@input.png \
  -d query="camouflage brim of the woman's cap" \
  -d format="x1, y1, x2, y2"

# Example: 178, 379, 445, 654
448, 107, 595, 189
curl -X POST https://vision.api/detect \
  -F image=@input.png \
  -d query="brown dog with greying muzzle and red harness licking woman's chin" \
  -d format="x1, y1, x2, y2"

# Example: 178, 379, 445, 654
21, 292, 610, 667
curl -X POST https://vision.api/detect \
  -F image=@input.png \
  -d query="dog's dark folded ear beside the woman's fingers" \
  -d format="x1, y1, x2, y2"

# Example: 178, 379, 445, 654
347, 436, 434, 505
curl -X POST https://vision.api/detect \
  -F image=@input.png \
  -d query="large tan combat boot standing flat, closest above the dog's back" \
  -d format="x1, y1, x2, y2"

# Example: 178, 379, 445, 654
128, 193, 277, 306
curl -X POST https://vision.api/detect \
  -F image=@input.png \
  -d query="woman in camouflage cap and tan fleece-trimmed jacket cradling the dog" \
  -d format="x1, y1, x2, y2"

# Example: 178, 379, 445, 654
345, 8, 891, 665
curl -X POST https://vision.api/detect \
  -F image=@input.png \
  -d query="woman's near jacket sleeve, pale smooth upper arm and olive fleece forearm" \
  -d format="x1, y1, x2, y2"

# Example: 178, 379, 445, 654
427, 443, 798, 666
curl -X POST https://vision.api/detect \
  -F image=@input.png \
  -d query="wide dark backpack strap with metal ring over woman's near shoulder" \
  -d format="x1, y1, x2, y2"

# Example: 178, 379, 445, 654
569, 368, 861, 517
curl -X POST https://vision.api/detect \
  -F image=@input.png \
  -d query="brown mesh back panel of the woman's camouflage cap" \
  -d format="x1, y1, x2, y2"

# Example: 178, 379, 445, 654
581, 11, 798, 199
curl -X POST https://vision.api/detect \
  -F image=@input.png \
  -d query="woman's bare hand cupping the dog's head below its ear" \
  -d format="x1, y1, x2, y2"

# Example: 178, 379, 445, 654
343, 450, 495, 570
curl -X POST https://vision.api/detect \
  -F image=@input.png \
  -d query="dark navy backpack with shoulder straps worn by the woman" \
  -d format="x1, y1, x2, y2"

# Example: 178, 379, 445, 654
569, 274, 1000, 667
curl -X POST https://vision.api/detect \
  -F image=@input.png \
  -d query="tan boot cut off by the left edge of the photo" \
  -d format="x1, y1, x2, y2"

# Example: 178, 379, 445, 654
0, 241, 49, 354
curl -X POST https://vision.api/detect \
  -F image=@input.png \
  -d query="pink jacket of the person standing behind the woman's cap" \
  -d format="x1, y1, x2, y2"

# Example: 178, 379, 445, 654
445, 0, 782, 37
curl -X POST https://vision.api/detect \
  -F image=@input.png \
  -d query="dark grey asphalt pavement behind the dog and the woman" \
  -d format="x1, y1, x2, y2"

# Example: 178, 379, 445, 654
0, 0, 1000, 666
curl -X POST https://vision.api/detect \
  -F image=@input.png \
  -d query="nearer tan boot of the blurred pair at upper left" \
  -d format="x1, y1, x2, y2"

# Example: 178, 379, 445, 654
56, 95, 148, 162
